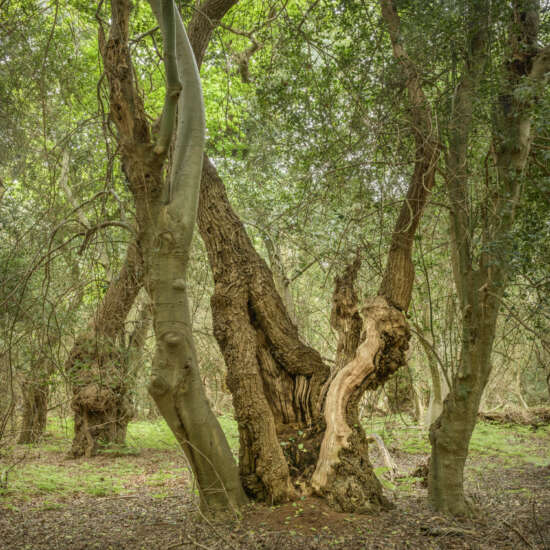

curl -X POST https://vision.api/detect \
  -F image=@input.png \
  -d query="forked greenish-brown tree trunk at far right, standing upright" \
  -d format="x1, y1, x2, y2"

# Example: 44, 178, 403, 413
428, 0, 550, 516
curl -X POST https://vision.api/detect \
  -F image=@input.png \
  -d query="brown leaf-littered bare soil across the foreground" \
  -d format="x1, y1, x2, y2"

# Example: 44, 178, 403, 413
0, 451, 550, 550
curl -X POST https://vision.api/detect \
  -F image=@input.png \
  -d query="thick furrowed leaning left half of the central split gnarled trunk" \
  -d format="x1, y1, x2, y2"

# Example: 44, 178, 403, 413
198, 157, 328, 502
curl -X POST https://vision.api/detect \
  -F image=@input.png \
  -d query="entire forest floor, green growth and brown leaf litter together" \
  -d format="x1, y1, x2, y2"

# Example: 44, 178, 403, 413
0, 417, 550, 550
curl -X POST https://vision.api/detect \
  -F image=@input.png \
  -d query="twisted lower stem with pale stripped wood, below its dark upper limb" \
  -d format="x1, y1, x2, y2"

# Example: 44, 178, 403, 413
312, 296, 409, 512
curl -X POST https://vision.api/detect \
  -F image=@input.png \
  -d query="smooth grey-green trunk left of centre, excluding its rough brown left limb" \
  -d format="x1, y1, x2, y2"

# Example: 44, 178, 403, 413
145, 0, 246, 514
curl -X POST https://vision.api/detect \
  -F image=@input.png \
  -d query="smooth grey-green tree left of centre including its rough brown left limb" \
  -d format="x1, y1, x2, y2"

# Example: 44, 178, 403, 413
96, 0, 245, 514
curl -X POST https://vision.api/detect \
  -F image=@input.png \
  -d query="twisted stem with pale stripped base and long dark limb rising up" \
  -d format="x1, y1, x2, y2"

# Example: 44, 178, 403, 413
312, 0, 439, 511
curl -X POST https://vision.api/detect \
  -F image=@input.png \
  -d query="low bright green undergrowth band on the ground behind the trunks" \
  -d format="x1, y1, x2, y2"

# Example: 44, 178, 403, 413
0, 416, 550, 509
